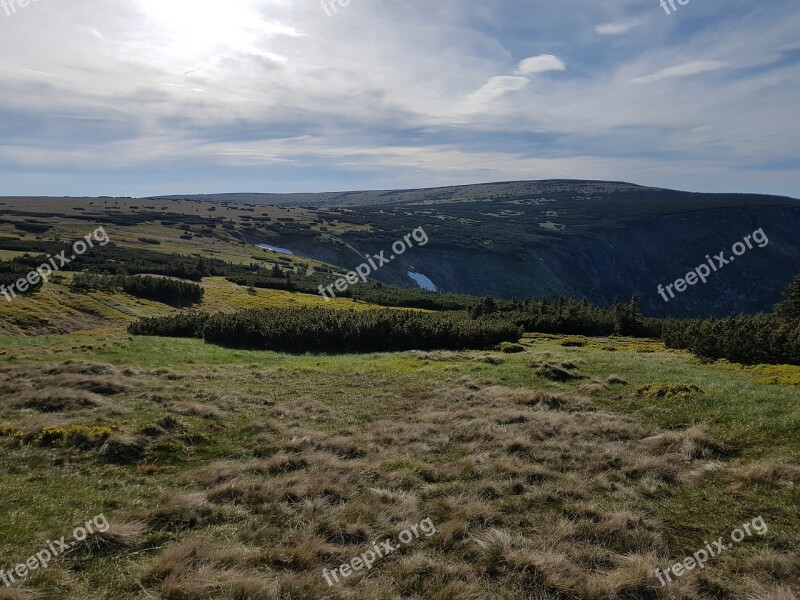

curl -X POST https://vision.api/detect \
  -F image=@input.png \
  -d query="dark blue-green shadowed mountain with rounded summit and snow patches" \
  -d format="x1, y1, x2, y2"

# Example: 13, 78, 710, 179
172, 181, 800, 316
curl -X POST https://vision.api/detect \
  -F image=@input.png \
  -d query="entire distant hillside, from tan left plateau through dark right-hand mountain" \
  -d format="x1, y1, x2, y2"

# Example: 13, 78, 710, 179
0, 181, 800, 317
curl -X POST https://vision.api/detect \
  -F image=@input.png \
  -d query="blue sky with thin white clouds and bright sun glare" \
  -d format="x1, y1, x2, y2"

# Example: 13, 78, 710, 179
0, 0, 800, 197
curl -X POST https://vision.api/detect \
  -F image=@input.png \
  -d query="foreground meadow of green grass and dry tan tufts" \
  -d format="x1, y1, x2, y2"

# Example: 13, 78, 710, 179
0, 328, 800, 600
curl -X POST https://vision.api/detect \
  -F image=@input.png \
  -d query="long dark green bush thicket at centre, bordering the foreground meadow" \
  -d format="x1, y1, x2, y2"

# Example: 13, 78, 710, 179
128, 308, 522, 354
